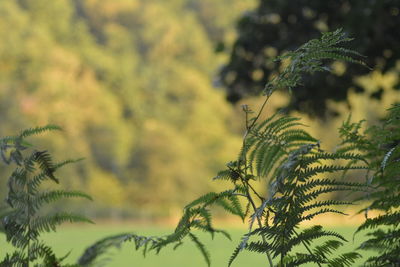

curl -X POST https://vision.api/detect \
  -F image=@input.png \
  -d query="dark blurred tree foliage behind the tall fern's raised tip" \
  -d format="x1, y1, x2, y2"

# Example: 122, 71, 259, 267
220, 0, 400, 117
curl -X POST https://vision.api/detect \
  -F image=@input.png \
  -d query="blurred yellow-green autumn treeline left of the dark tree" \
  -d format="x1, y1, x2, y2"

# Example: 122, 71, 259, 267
0, 0, 254, 219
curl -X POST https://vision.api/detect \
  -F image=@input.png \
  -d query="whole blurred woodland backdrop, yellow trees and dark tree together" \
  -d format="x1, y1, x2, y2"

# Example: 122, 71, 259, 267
0, 0, 400, 224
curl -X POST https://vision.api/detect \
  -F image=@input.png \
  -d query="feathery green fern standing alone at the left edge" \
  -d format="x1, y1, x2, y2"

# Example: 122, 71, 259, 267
0, 125, 91, 267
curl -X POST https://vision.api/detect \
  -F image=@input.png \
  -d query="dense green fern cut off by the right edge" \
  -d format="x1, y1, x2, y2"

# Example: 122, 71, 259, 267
357, 104, 400, 266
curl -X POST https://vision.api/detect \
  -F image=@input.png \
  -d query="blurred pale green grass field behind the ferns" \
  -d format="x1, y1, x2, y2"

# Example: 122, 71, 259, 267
0, 225, 376, 267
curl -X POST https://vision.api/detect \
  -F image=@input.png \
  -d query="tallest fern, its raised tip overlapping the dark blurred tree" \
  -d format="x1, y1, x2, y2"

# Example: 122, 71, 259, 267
76, 30, 376, 266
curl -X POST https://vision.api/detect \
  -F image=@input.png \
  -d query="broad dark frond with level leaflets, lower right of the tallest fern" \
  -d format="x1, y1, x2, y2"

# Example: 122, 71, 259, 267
230, 140, 367, 266
